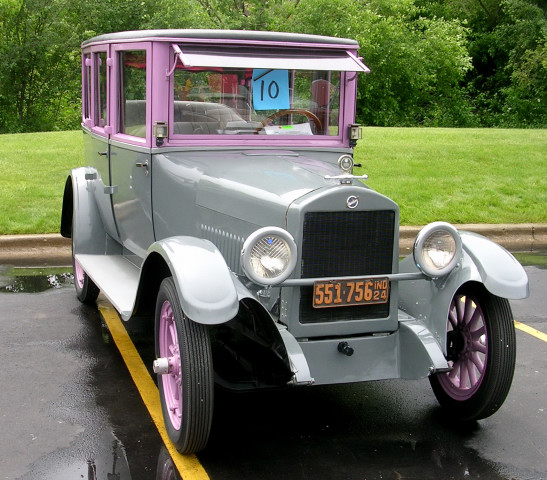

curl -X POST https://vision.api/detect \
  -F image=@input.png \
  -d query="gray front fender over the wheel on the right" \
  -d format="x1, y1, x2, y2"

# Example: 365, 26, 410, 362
399, 232, 529, 353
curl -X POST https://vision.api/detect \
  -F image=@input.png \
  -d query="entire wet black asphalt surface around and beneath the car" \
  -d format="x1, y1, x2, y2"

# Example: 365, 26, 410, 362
0, 260, 547, 480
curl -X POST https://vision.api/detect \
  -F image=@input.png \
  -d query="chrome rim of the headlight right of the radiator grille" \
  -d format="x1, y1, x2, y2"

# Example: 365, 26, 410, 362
413, 222, 462, 278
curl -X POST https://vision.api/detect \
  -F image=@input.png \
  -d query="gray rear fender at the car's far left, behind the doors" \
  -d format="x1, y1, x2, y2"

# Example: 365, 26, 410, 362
61, 167, 106, 254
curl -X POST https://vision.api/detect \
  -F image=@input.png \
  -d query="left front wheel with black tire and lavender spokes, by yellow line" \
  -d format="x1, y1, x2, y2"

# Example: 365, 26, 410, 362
155, 277, 214, 454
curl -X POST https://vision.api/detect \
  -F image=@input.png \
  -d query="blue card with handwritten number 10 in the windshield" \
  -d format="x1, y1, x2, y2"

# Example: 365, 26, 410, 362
253, 68, 290, 110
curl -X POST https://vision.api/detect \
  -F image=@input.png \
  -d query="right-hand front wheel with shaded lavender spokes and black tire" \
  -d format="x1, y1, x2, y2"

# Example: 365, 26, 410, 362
429, 284, 516, 421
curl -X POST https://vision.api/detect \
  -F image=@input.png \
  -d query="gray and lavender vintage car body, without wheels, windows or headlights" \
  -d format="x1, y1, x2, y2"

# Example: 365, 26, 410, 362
61, 31, 528, 388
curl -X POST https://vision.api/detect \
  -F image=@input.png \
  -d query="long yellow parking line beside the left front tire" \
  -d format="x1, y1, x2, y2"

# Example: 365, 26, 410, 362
97, 300, 209, 480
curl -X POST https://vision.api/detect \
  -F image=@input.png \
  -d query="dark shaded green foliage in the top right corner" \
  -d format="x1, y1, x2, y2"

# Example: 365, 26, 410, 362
421, 0, 547, 127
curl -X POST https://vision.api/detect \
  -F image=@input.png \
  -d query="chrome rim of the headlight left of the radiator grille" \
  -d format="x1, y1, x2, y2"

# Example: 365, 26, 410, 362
241, 227, 297, 286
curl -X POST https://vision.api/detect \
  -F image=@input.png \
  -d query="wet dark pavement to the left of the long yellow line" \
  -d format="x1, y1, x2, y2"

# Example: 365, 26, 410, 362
0, 282, 162, 480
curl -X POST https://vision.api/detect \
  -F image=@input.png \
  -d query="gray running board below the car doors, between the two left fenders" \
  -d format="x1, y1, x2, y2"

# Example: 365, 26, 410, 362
75, 254, 141, 320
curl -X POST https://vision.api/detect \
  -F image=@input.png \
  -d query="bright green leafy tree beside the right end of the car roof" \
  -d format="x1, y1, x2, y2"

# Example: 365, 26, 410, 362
279, 0, 473, 126
